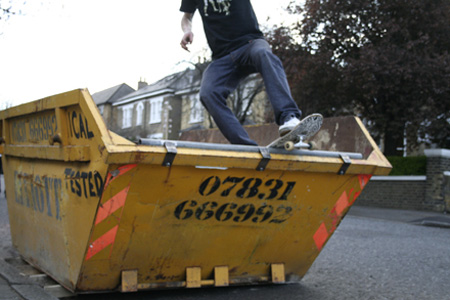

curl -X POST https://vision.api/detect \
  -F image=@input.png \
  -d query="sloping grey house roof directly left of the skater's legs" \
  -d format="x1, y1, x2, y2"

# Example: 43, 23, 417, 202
115, 65, 205, 105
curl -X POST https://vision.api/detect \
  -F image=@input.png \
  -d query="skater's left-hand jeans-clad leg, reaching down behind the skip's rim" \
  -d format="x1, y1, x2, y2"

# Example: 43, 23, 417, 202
200, 56, 257, 145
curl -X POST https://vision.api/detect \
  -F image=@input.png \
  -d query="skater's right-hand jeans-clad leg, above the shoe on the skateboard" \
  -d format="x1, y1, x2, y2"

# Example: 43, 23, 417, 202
235, 39, 301, 125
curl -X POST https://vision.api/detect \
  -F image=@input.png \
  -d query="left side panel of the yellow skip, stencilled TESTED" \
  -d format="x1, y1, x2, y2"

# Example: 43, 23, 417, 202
0, 90, 107, 290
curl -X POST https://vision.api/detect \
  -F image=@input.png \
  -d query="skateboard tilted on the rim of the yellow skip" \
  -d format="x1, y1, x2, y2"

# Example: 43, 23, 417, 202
267, 114, 323, 151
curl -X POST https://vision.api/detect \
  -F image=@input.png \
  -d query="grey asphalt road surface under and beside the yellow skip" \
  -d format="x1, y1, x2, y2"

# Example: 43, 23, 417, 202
0, 175, 450, 300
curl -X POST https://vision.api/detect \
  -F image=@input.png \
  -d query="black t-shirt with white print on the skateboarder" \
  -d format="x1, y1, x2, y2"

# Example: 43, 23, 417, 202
180, 0, 263, 59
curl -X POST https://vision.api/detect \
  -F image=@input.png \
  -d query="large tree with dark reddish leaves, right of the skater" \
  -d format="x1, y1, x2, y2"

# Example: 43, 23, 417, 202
270, 0, 450, 155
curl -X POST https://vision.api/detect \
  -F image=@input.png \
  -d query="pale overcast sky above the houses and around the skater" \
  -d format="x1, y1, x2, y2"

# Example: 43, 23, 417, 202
0, 0, 298, 109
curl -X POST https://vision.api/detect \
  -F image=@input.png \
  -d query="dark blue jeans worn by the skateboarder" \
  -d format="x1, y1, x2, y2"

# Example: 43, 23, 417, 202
200, 39, 301, 145
